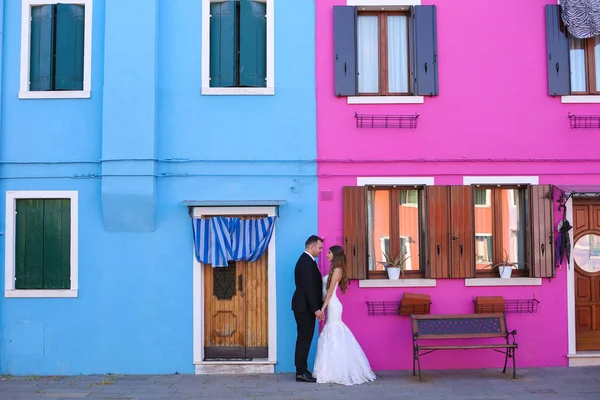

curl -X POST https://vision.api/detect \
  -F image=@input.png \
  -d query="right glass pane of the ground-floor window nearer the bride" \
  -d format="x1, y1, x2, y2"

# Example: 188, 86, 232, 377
392, 190, 420, 271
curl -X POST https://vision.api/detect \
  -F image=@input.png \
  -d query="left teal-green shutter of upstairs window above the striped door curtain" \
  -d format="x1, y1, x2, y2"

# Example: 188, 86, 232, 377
210, 1, 239, 87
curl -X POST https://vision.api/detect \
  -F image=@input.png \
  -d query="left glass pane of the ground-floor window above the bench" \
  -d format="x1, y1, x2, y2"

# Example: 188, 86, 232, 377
475, 189, 494, 269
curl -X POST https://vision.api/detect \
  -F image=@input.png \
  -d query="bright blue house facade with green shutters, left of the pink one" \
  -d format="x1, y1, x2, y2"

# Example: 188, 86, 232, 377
0, 0, 317, 375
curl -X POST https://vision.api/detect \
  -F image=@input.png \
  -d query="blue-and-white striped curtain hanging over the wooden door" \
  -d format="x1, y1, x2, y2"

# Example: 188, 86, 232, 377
192, 217, 276, 267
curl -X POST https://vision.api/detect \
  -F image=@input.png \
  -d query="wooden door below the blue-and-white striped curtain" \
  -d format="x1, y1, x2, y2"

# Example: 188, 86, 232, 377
204, 252, 269, 359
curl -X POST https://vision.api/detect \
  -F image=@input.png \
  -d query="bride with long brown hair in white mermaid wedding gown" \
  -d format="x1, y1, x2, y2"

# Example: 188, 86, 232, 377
313, 246, 375, 385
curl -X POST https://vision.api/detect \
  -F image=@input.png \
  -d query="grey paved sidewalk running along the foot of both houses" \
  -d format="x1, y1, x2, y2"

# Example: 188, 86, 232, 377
0, 367, 600, 400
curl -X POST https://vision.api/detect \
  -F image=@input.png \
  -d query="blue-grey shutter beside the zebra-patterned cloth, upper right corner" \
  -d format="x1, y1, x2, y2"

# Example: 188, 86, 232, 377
546, 4, 571, 96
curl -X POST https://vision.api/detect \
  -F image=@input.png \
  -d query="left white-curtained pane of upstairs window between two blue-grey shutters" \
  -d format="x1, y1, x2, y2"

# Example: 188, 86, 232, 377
357, 15, 379, 93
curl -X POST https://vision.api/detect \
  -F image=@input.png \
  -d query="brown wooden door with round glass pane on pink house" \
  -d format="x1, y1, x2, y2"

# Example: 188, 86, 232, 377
573, 199, 600, 351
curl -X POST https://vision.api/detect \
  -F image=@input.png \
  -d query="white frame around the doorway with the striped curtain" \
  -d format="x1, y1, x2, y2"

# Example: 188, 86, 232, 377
192, 206, 277, 374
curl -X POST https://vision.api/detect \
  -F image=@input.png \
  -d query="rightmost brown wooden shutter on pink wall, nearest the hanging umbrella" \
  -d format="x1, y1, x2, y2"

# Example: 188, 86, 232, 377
529, 185, 555, 278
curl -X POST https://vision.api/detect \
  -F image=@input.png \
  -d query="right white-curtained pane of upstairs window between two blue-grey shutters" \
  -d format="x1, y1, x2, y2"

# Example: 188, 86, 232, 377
388, 15, 408, 93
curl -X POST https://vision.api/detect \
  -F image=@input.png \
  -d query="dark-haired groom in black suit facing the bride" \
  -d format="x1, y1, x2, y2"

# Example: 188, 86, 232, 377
292, 235, 323, 382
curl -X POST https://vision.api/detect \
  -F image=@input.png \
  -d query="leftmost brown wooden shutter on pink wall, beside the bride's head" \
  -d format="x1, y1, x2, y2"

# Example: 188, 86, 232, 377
343, 186, 368, 279
